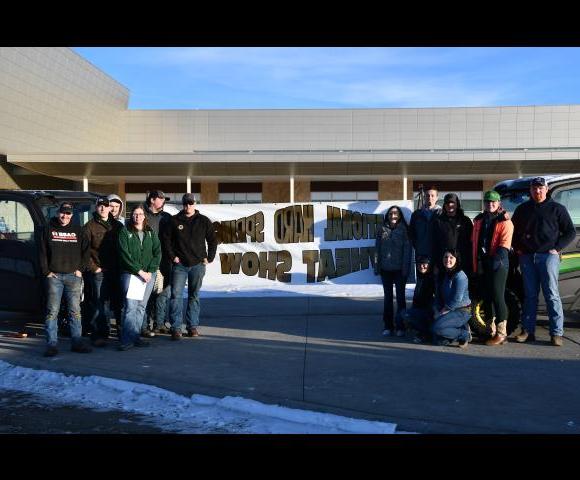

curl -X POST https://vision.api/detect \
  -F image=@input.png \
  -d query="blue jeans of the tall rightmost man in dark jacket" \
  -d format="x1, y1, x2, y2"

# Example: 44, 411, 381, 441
520, 253, 564, 336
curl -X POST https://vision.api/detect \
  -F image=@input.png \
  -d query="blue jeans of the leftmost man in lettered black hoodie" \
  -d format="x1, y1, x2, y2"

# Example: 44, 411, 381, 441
44, 273, 83, 347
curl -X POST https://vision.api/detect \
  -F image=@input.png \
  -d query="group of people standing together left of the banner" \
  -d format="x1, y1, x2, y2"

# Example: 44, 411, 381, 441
38, 190, 217, 357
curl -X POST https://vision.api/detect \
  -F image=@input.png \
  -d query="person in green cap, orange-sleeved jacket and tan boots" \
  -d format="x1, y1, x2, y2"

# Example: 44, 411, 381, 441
471, 190, 514, 346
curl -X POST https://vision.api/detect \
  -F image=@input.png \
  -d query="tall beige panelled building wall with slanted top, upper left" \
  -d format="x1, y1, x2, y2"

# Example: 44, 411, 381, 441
0, 47, 129, 154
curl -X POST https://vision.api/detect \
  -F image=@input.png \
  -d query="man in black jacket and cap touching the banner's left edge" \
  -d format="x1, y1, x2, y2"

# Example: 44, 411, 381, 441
162, 193, 217, 340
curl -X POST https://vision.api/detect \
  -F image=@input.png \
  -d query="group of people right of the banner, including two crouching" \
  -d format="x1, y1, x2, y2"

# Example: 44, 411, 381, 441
375, 177, 576, 348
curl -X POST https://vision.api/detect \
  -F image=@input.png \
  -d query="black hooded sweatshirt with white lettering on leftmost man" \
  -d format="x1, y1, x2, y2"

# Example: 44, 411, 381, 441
38, 217, 89, 277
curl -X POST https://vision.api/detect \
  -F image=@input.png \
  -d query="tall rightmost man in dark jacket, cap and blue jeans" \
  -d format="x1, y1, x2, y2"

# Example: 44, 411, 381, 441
512, 177, 576, 347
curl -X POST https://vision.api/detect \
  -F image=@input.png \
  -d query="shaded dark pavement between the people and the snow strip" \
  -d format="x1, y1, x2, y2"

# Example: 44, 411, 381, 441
0, 297, 580, 434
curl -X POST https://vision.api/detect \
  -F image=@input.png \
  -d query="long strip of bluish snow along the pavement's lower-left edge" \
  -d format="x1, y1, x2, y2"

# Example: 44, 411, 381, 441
0, 360, 396, 434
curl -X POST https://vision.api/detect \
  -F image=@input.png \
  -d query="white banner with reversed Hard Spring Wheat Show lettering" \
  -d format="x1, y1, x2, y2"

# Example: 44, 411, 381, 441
198, 200, 412, 288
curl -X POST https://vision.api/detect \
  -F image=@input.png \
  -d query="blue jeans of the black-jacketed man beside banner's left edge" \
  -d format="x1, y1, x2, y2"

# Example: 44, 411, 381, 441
171, 263, 205, 332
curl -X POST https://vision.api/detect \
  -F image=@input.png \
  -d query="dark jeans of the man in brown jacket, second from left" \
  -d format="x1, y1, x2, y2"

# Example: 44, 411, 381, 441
86, 272, 118, 339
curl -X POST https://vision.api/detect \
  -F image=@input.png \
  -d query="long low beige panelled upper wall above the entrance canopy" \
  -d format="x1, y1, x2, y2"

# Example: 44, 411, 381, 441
120, 105, 580, 153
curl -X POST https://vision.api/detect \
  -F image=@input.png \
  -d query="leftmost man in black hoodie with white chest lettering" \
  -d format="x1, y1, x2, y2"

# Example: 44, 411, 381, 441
38, 202, 91, 357
